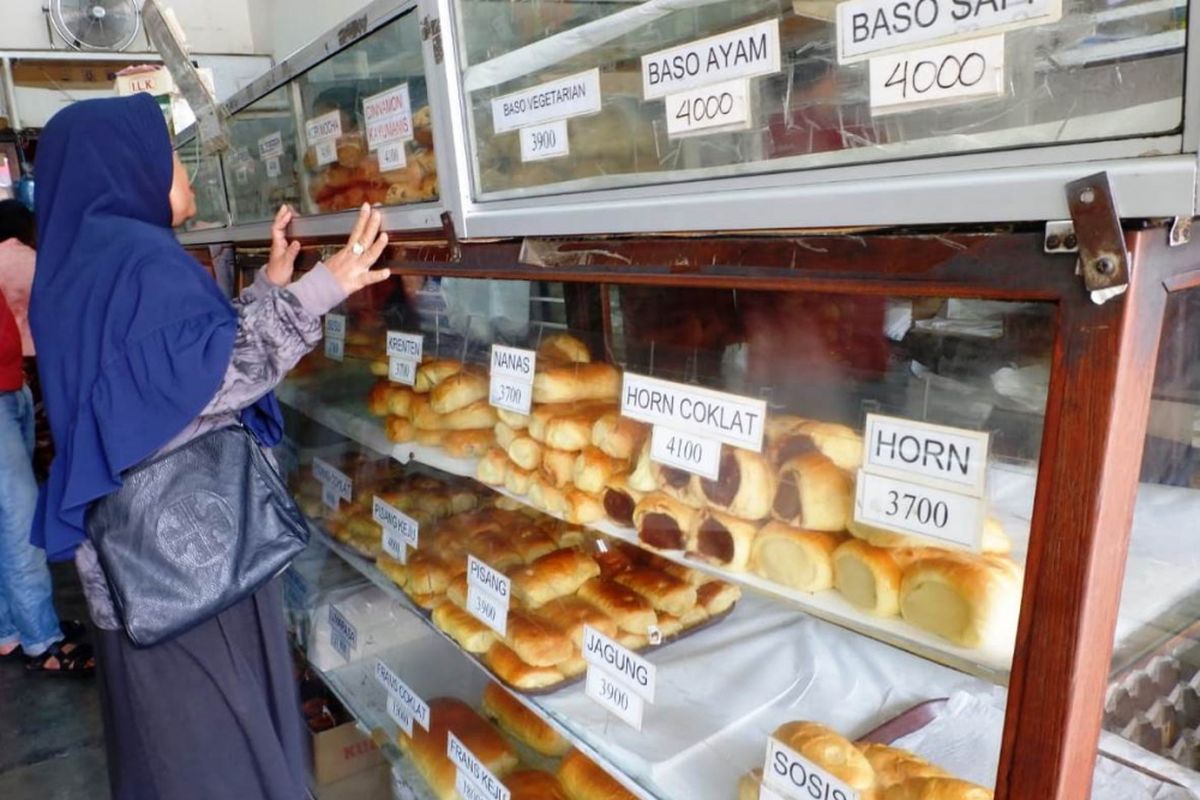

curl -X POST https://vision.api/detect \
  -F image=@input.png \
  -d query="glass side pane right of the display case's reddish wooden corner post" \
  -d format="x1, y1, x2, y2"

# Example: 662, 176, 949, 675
1096, 289, 1200, 800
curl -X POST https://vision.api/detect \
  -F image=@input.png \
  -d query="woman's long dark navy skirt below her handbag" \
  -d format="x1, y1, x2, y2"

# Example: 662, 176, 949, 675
96, 582, 307, 800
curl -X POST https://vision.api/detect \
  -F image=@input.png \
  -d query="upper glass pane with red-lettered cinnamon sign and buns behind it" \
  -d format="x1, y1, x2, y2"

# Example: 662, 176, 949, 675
298, 13, 438, 211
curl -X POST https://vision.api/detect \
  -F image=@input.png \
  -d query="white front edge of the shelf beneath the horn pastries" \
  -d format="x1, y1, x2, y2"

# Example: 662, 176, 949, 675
280, 384, 1012, 685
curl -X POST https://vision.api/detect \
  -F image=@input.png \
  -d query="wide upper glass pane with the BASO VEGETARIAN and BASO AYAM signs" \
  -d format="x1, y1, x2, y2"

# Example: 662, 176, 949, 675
457, 0, 1187, 198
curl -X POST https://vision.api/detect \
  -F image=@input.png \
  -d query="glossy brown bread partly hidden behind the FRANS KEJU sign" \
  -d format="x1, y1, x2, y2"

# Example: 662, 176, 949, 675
401, 697, 517, 800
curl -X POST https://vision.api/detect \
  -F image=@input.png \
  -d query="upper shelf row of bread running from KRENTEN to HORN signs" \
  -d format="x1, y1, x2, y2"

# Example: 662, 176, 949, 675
281, 336, 1031, 684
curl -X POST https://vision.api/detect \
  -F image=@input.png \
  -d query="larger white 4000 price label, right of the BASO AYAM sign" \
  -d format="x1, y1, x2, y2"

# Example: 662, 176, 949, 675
870, 34, 1004, 115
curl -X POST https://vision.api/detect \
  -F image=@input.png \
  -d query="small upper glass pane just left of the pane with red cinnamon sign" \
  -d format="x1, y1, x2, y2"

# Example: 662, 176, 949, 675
224, 86, 300, 224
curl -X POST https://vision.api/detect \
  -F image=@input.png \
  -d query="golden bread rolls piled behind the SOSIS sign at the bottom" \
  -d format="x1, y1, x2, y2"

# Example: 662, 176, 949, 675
738, 721, 992, 800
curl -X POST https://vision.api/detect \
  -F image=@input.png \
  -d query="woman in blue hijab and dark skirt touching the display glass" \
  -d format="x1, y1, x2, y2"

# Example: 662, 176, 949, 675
30, 95, 388, 800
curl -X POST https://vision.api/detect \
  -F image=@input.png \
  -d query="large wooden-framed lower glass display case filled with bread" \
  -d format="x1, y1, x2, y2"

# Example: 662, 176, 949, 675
240, 215, 1200, 800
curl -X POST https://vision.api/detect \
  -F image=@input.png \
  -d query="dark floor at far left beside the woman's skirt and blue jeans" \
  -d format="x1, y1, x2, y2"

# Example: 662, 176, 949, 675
0, 564, 108, 800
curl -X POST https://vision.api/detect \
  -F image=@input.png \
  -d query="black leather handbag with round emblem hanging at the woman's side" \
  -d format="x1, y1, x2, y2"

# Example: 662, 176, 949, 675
88, 426, 308, 646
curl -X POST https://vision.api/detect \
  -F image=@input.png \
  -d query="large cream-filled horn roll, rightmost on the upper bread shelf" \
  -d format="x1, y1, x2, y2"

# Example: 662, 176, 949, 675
900, 552, 1021, 648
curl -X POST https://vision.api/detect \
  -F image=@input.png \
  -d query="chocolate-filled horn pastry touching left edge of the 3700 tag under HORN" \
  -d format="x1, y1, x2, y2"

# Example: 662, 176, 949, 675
772, 453, 853, 531
